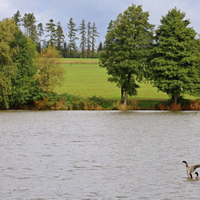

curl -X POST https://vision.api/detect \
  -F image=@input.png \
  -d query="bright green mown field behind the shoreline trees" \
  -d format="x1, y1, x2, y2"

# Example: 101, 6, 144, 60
55, 58, 197, 101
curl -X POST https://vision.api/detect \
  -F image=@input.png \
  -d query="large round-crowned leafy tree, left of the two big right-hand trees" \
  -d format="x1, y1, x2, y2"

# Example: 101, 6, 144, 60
100, 4, 154, 105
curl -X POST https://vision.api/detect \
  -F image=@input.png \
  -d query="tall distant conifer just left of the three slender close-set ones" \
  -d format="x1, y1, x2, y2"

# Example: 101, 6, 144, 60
67, 18, 78, 57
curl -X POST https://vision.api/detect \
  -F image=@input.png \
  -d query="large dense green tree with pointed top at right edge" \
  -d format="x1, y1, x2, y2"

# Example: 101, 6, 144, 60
149, 8, 200, 104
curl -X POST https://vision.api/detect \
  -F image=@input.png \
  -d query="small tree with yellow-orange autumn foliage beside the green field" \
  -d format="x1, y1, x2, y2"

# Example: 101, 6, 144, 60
35, 46, 64, 93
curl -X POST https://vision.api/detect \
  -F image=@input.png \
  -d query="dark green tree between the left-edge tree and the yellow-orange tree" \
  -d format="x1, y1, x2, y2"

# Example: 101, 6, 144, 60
9, 30, 37, 107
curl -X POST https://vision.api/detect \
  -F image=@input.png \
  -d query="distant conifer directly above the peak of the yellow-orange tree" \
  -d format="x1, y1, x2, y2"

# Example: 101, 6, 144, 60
45, 19, 56, 46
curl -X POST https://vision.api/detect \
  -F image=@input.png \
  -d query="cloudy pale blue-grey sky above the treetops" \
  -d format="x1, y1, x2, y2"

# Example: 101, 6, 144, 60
0, 0, 200, 42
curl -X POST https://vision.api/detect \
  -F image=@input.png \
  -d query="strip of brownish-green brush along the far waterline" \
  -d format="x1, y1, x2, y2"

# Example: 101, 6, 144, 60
16, 98, 200, 111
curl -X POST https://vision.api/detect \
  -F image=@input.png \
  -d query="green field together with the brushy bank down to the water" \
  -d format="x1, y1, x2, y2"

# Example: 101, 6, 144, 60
18, 58, 200, 110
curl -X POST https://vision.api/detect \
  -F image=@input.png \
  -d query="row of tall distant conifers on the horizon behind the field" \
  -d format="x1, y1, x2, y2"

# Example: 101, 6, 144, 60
14, 10, 103, 58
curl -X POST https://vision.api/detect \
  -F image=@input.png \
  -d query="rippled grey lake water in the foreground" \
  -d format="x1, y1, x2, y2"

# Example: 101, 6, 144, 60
0, 111, 200, 200
